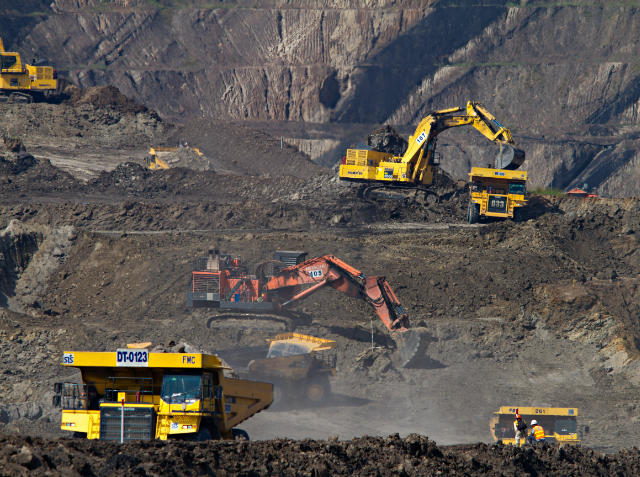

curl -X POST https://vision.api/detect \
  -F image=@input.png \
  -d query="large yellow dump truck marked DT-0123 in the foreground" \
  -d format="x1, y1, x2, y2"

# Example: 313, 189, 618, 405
54, 348, 273, 441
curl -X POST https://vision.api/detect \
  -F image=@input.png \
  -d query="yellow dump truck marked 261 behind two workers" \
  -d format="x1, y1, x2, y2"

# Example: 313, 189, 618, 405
489, 406, 587, 444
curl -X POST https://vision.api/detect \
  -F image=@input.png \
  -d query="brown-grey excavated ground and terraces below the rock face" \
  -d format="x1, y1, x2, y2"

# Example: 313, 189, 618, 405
0, 89, 640, 475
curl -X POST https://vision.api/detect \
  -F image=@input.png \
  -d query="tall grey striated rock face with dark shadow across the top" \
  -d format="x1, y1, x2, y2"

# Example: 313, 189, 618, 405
6, 0, 640, 196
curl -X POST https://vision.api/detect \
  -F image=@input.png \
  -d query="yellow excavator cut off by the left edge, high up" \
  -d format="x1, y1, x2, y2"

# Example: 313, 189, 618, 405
0, 38, 58, 103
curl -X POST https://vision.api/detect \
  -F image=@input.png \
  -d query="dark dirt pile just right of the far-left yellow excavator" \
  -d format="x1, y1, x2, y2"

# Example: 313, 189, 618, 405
61, 84, 155, 115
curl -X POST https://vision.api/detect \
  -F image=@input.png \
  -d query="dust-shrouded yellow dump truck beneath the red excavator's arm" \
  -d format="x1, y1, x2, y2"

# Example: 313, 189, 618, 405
217, 333, 337, 404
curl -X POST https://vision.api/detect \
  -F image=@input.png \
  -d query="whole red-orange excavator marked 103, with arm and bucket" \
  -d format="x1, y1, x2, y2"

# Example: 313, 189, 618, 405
187, 250, 420, 364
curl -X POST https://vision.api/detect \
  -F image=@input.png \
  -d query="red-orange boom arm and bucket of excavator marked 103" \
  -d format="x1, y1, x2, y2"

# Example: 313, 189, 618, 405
264, 255, 420, 364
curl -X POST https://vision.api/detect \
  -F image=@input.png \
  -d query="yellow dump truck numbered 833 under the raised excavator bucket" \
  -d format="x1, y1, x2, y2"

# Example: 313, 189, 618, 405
467, 167, 527, 224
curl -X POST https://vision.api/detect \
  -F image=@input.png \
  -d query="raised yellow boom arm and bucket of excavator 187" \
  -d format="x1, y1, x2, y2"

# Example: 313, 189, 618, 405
401, 101, 525, 174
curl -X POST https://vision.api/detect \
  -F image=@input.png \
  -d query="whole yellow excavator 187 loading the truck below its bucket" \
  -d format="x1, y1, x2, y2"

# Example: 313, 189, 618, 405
339, 101, 525, 197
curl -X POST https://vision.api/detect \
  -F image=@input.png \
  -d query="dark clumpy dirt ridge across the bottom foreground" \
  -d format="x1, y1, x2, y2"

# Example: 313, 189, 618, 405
0, 434, 640, 477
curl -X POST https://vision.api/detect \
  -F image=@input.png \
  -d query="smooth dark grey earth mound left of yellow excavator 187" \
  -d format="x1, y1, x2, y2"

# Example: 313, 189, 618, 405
164, 118, 327, 179
